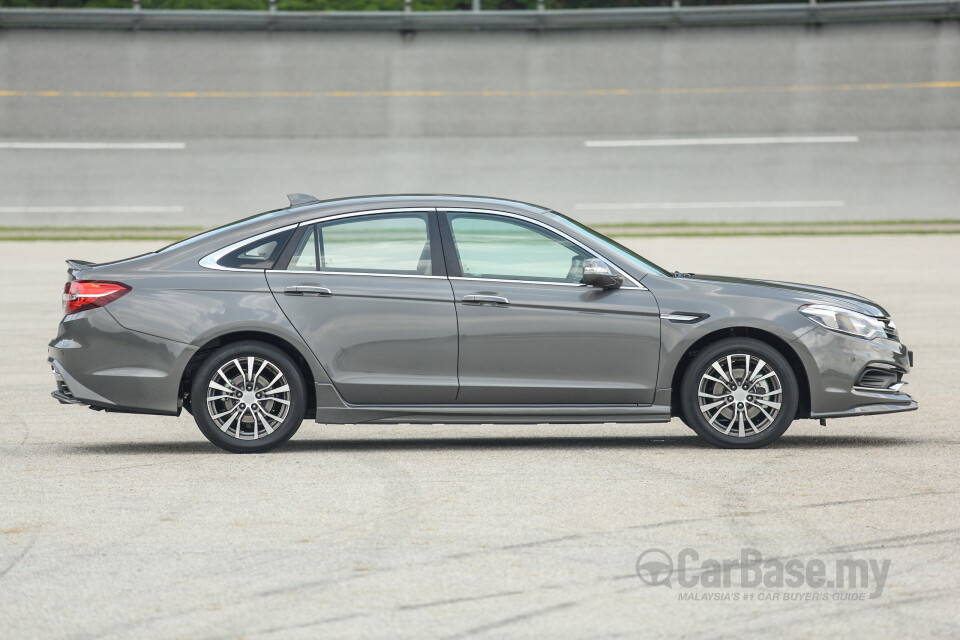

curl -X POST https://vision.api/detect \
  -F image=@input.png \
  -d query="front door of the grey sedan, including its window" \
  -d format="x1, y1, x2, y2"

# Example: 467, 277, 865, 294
442, 211, 660, 404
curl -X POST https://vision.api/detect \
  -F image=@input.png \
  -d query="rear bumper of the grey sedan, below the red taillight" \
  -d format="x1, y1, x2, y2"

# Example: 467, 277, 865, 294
47, 308, 196, 415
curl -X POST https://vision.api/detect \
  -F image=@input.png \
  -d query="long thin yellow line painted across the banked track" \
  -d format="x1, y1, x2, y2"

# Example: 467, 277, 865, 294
0, 80, 960, 99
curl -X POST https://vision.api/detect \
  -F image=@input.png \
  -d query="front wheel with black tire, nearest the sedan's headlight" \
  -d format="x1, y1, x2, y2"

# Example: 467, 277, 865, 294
680, 338, 799, 449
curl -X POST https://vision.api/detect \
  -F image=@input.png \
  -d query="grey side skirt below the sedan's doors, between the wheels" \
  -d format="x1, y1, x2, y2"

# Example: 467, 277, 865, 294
316, 384, 670, 424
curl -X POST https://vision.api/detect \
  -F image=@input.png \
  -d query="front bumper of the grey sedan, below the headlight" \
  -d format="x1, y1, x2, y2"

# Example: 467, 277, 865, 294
797, 327, 918, 418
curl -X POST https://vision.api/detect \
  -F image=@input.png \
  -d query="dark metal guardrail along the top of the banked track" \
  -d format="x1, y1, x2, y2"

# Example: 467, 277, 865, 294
0, 0, 960, 31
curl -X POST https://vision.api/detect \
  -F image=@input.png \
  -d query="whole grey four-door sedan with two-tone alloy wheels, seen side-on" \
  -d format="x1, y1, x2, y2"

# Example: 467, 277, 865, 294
49, 194, 917, 452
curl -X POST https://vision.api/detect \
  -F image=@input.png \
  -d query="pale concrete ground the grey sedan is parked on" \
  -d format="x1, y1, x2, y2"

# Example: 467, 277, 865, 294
0, 235, 960, 638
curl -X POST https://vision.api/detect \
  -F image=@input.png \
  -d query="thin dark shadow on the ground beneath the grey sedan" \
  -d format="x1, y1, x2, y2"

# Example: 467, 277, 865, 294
61, 434, 930, 455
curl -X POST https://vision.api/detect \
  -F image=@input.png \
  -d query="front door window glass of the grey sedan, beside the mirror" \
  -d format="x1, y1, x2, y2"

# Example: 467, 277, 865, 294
450, 213, 593, 283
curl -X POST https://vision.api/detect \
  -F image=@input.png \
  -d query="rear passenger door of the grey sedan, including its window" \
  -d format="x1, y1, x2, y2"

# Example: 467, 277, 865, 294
267, 211, 458, 404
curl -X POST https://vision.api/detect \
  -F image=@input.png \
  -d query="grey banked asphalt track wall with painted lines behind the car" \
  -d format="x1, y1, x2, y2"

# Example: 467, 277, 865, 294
0, 23, 960, 226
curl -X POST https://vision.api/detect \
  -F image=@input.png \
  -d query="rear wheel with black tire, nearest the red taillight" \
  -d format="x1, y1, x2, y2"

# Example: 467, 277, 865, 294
190, 341, 307, 453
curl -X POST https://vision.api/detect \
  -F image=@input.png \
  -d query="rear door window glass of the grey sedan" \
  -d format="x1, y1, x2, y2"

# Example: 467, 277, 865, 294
288, 213, 433, 275
